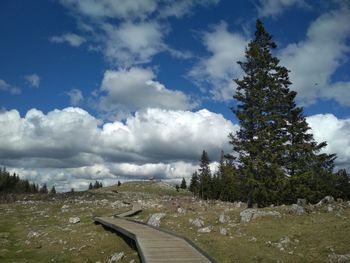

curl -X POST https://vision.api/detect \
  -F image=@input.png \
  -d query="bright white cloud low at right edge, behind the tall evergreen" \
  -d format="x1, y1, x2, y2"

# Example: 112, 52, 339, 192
307, 114, 350, 170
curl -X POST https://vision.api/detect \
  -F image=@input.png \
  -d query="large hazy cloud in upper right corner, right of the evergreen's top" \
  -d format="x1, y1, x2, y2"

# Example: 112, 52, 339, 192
279, 6, 350, 106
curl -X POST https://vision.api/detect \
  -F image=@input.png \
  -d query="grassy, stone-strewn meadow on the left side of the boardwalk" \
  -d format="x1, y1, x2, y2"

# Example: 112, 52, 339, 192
0, 193, 139, 263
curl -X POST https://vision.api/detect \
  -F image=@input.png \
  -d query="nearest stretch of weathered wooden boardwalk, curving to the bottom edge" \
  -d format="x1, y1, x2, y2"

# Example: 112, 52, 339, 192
95, 217, 216, 263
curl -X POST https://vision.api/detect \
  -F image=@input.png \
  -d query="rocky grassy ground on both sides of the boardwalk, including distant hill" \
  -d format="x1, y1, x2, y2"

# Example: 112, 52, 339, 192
0, 182, 350, 262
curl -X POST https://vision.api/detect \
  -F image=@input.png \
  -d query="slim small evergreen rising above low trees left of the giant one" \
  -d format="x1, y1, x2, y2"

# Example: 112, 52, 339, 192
199, 150, 212, 200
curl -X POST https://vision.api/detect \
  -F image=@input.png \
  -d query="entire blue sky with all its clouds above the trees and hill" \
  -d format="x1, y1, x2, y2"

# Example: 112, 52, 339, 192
0, 0, 350, 191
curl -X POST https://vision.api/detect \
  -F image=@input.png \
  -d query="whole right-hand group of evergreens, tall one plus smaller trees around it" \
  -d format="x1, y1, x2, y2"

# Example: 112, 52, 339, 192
189, 20, 350, 207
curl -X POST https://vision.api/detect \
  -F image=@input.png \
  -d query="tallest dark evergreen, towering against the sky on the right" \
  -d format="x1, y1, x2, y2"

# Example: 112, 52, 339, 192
229, 20, 335, 207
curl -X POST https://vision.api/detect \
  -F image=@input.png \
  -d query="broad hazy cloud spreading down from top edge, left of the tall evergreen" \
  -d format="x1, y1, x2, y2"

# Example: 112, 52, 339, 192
57, 0, 219, 67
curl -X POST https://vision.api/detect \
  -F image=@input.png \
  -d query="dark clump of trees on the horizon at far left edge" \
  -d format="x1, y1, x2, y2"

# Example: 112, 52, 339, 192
0, 168, 38, 193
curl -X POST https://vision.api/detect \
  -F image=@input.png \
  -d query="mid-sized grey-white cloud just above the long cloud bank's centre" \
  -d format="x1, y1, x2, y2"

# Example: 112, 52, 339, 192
98, 67, 192, 111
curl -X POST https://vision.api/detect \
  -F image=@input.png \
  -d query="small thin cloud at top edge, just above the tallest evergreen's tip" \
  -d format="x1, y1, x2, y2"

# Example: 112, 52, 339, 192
257, 0, 307, 17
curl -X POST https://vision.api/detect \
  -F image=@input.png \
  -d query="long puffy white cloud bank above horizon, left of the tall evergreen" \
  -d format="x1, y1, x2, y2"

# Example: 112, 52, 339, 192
0, 107, 237, 190
